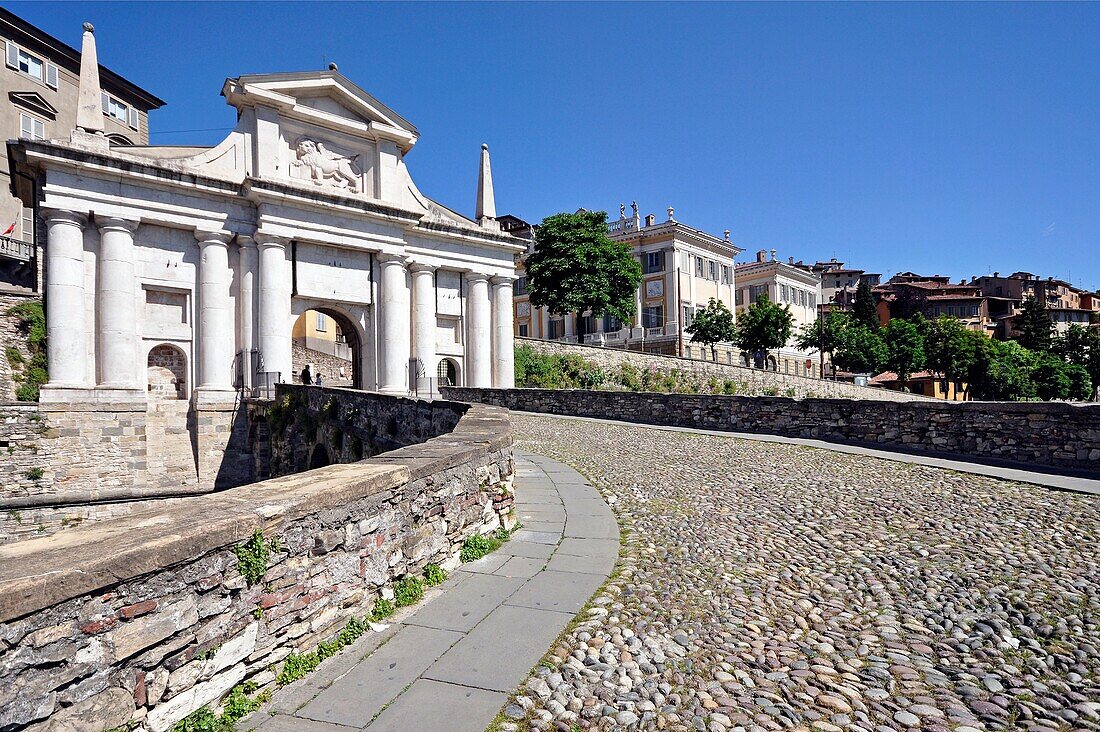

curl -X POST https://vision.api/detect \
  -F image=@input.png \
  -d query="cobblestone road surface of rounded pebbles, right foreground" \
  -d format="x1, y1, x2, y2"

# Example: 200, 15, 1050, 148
501, 414, 1100, 732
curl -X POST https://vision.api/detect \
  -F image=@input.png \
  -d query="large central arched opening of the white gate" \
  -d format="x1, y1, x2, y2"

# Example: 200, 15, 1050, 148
290, 307, 363, 389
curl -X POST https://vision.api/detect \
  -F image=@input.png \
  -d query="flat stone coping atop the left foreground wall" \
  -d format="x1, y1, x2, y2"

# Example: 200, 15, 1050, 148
0, 397, 512, 622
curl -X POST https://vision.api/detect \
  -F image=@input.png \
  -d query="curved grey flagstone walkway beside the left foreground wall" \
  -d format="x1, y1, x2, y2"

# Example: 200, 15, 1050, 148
240, 451, 619, 732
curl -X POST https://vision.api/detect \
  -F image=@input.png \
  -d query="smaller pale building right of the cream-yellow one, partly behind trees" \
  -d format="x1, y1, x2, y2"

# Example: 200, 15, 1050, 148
734, 249, 822, 376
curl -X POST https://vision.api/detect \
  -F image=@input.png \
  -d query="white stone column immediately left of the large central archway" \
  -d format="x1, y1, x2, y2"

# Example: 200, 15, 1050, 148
256, 232, 294, 383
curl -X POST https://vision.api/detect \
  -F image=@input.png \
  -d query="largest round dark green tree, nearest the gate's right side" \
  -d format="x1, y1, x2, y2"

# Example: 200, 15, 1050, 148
526, 211, 641, 335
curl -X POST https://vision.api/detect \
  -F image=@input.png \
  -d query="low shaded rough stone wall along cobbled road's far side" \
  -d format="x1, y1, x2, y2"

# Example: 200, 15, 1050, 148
443, 387, 1100, 476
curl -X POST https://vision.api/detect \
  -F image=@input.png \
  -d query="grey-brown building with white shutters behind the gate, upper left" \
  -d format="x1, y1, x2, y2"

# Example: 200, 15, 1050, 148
0, 8, 164, 294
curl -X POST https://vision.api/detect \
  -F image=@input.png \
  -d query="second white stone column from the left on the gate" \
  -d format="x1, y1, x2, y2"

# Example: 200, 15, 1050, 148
96, 218, 140, 389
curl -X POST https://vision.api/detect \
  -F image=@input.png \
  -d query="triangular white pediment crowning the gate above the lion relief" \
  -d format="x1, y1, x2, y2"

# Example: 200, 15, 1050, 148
222, 70, 419, 151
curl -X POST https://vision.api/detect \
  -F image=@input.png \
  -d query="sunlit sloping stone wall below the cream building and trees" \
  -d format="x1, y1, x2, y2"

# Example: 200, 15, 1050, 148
516, 338, 927, 402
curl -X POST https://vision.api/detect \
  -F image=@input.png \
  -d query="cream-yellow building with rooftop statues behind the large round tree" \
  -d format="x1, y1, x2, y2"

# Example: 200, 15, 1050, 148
512, 205, 741, 362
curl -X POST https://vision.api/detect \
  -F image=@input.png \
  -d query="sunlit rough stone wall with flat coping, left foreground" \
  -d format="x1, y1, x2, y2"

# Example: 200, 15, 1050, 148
0, 390, 514, 732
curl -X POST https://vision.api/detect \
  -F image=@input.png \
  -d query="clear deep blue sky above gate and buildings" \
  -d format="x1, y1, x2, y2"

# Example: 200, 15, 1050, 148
8, 2, 1100, 288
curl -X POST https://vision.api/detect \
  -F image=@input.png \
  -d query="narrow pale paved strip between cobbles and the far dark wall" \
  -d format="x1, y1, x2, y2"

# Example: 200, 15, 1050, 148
514, 411, 1100, 495
